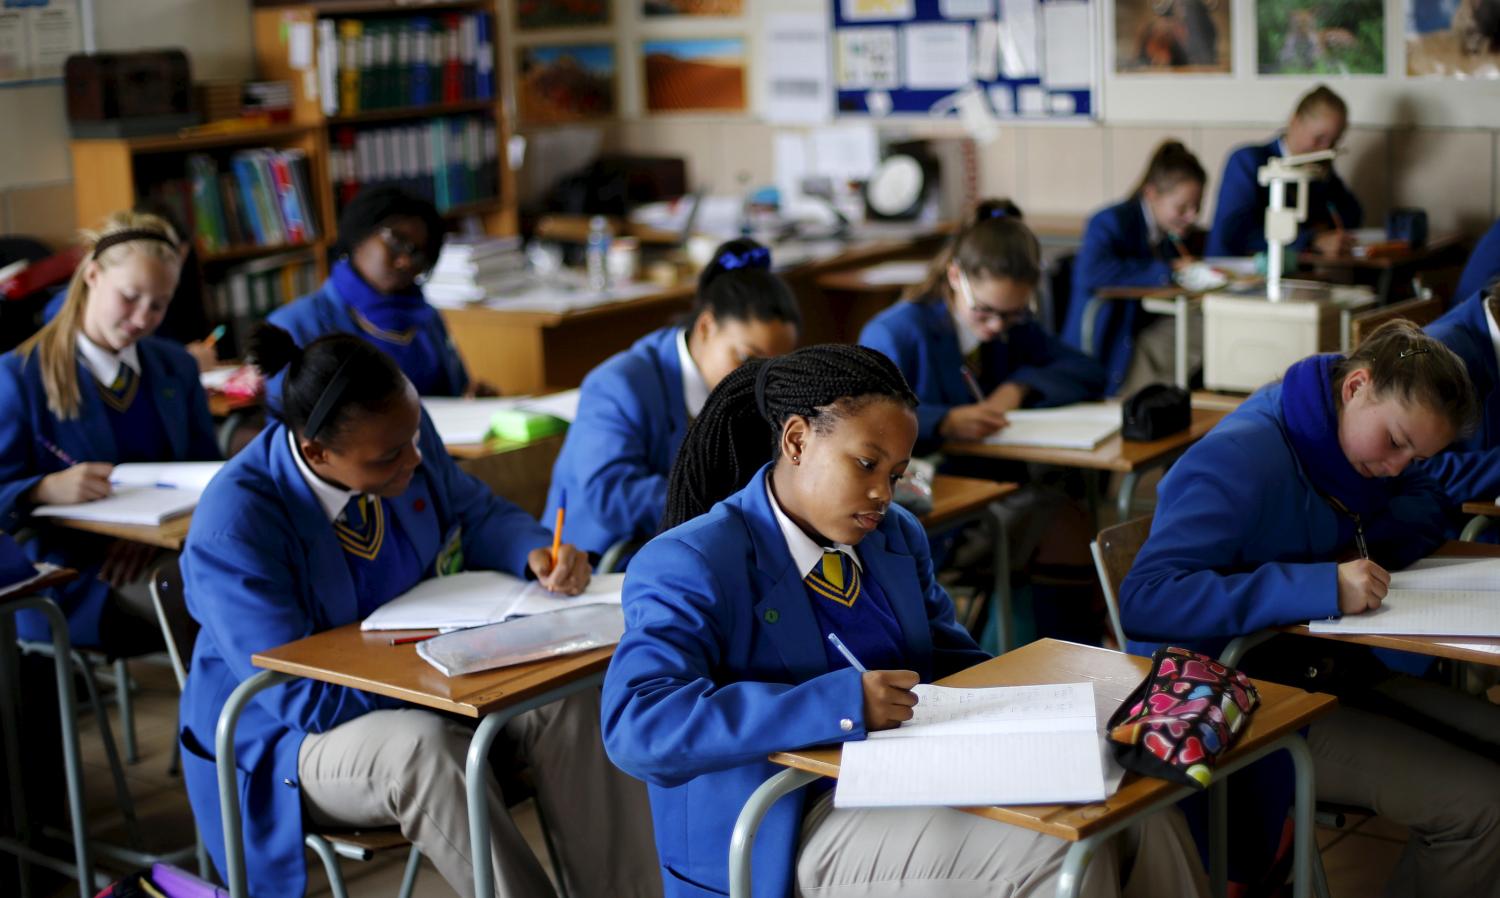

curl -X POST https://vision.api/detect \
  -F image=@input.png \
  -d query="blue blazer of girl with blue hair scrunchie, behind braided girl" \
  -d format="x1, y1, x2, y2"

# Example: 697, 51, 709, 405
542, 327, 687, 563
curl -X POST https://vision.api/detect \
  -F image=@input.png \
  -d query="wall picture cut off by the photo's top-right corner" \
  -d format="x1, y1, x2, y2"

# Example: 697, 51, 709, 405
1407, 0, 1500, 78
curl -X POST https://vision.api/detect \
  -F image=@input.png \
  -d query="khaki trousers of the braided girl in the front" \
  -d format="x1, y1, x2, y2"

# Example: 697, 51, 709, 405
797, 793, 1209, 898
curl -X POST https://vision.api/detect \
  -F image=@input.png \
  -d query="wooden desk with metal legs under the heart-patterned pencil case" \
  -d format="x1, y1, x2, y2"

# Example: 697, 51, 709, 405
729, 639, 1338, 897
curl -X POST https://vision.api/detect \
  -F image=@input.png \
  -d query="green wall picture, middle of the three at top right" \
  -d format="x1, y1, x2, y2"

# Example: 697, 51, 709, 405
1256, 0, 1386, 75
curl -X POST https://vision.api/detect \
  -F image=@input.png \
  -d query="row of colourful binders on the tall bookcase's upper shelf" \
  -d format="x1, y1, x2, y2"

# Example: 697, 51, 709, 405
318, 12, 495, 115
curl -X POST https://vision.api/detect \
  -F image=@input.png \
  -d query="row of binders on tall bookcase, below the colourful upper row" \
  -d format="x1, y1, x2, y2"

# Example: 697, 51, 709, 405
329, 115, 500, 210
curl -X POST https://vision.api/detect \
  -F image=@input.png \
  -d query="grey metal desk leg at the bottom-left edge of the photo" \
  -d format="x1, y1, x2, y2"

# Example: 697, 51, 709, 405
0, 595, 95, 898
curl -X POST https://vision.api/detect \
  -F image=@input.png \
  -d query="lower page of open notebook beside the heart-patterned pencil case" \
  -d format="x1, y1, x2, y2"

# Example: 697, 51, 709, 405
834, 734, 1104, 808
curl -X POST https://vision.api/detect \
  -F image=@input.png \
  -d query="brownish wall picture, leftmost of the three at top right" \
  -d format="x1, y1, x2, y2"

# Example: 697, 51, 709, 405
1115, 0, 1233, 75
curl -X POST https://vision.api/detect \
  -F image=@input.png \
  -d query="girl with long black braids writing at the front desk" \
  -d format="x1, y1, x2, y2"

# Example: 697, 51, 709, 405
603, 343, 1205, 898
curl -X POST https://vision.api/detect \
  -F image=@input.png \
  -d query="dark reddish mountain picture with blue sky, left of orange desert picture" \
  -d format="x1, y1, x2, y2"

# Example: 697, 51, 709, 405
516, 43, 615, 124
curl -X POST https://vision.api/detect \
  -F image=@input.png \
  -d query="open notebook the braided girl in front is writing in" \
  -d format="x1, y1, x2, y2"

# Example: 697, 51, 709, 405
834, 682, 1119, 808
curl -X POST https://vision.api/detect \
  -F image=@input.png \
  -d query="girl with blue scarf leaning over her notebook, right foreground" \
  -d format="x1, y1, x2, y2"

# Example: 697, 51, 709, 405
1121, 321, 1500, 895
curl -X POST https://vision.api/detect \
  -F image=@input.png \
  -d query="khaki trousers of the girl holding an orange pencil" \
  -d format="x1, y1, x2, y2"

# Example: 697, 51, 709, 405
297, 690, 662, 898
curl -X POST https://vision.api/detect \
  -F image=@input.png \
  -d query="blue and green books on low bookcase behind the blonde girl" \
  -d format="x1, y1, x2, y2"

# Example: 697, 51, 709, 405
157, 150, 318, 253
